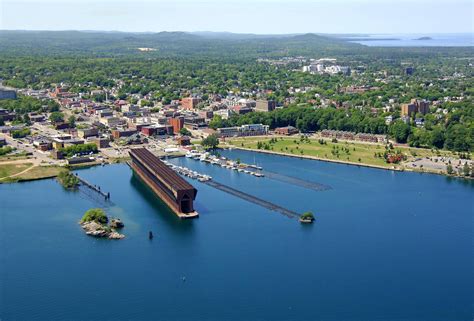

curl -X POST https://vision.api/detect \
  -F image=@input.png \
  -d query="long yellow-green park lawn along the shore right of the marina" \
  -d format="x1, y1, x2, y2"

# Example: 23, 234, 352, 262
229, 136, 460, 167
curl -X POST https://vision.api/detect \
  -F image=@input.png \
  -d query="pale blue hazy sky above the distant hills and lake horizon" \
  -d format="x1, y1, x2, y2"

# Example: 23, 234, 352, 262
0, 0, 474, 34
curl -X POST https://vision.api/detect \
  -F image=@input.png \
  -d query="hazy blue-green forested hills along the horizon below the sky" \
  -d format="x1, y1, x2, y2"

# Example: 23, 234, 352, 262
0, 30, 361, 58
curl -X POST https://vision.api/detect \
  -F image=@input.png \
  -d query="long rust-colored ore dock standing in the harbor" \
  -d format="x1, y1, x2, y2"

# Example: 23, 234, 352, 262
130, 148, 199, 218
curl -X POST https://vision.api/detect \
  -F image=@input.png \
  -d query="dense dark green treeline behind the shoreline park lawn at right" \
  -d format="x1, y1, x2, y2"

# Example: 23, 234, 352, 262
210, 105, 474, 151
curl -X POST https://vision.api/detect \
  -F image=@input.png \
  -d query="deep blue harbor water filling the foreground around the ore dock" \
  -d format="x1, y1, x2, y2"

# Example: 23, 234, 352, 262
0, 151, 474, 321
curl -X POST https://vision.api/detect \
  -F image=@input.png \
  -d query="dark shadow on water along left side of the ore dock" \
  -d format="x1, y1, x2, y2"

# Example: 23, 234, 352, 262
130, 173, 193, 231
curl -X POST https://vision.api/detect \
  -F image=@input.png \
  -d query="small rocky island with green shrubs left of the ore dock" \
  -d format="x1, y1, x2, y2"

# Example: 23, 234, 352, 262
79, 208, 125, 240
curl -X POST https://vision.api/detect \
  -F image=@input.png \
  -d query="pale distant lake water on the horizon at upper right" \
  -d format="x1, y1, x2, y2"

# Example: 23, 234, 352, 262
347, 33, 474, 47
